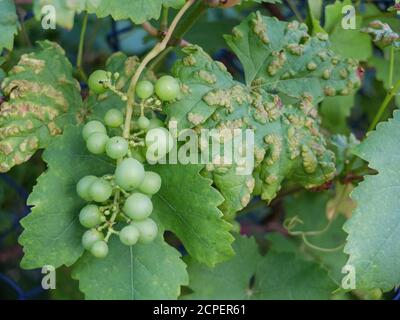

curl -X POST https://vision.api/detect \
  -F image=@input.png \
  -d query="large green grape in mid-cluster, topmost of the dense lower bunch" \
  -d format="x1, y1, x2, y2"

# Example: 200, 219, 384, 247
115, 158, 144, 191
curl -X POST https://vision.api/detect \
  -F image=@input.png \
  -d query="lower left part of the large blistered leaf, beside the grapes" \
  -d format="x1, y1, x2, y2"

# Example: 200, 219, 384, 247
166, 46, 340, 206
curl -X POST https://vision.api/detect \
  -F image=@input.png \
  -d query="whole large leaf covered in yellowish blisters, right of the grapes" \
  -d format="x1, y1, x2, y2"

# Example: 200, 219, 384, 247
166, 13, 360, 215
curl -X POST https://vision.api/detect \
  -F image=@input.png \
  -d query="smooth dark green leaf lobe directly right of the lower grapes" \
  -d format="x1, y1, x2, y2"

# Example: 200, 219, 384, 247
149, 164, 238, 266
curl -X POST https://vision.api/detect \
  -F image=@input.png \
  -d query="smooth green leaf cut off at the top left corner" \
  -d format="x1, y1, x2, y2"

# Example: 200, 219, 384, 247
0, 0, 19, 52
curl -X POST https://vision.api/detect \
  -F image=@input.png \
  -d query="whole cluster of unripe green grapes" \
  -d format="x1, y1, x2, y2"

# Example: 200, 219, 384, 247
76, 70, 180, 258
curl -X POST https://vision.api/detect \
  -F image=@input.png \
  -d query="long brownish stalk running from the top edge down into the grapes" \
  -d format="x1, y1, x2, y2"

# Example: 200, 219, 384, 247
123, 0, 196, 139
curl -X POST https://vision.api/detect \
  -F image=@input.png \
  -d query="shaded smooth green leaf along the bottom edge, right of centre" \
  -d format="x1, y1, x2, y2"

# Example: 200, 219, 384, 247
183, 237, 335, 300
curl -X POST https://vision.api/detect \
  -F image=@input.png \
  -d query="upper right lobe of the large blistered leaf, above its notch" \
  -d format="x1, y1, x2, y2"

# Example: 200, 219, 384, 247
225, 13, 360, 103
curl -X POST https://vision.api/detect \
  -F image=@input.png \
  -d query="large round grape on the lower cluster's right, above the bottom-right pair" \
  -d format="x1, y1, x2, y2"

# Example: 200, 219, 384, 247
122, 192, 153, 220
